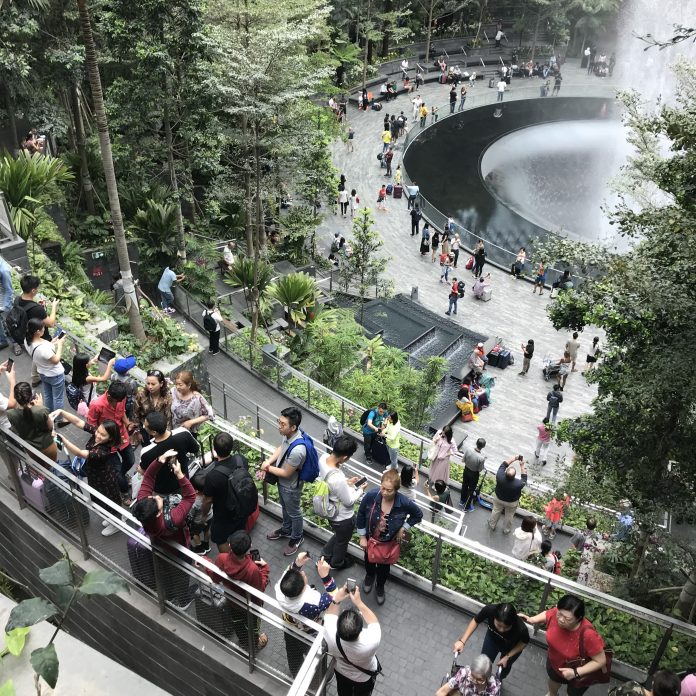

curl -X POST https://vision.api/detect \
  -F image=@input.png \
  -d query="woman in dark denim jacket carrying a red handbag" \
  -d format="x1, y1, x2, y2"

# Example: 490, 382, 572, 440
357, 469, 423, 605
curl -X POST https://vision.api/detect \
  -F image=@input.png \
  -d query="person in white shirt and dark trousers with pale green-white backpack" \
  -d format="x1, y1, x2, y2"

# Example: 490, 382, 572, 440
318, 435, 367, 570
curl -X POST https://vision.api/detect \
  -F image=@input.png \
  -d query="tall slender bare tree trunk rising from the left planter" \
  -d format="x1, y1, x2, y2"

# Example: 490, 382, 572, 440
77, 0, 146, 341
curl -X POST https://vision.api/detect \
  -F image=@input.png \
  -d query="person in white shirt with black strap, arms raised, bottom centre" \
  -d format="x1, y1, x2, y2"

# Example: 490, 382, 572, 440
324, 587, 382, 696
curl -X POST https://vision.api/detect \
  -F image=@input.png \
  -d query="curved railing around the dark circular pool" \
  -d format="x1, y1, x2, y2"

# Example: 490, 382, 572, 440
392, 78, 616, 280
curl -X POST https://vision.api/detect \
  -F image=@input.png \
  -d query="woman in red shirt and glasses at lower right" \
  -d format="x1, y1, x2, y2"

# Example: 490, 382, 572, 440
519, 595, 606, 696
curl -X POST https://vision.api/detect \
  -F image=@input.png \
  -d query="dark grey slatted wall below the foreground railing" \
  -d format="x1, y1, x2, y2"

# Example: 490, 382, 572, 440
0, 486, 287, 696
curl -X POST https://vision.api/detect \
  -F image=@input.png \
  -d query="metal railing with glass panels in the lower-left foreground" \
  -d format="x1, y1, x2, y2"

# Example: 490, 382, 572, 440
0, 429, 330, 696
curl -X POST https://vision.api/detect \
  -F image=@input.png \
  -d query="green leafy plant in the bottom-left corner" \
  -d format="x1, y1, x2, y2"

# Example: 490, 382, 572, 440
0, 551, 130, 696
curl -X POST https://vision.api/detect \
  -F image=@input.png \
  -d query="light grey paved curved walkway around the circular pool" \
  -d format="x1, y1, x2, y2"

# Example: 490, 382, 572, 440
320, 62, 607, 479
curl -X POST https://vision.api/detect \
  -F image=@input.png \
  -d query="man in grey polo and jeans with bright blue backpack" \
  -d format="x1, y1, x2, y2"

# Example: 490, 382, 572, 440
261, 406, 307, 556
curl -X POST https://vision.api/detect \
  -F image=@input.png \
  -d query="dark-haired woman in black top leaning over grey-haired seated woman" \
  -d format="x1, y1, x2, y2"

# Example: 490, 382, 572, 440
452, 603, 529, 680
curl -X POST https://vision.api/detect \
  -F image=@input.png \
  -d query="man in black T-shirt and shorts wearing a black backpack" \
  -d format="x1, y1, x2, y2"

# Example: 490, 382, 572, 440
197, 433, 259, 553
